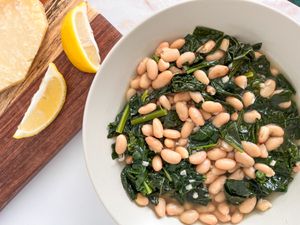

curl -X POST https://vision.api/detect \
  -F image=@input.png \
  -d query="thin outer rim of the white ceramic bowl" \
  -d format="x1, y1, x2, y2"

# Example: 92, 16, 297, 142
82, 0, 300, 224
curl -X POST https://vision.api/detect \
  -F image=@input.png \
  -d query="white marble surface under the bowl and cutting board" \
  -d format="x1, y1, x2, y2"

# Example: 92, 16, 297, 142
0, 0, 300, 225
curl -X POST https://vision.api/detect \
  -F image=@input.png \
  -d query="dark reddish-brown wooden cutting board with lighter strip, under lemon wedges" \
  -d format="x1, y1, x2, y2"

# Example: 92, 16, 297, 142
0, 0, 121, 209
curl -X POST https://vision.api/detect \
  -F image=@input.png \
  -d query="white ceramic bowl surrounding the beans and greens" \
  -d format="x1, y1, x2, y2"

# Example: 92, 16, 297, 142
83, 0, 300, 225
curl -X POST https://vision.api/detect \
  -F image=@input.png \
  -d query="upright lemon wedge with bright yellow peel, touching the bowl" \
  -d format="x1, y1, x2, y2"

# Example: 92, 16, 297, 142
61, 2, 101, 73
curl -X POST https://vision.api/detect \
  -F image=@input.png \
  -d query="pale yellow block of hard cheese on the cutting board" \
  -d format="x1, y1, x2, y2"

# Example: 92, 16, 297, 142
0, 0, 48, 92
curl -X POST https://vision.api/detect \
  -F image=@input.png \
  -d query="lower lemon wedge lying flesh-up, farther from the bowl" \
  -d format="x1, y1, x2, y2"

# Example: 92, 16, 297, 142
13, 63, 67, 139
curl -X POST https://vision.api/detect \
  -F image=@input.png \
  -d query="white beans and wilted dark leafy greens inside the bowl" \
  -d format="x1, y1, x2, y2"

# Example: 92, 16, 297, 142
108, 27, 300, 225
